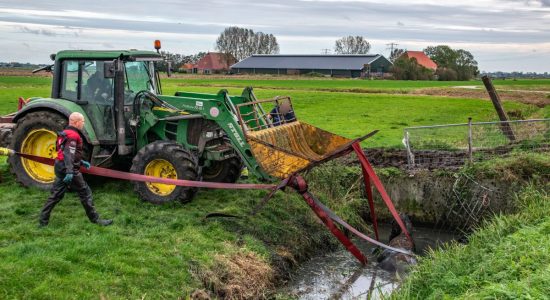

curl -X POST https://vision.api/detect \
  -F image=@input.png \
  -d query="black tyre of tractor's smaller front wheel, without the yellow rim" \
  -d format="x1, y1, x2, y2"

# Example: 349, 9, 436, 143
130, 141, 198, 204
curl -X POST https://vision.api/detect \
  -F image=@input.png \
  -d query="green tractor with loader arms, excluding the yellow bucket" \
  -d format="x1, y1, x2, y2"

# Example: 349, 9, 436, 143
3, 50, 276, 203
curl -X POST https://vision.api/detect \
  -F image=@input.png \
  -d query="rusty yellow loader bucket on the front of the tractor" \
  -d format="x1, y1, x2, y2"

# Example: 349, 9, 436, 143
237, 97, 353, 179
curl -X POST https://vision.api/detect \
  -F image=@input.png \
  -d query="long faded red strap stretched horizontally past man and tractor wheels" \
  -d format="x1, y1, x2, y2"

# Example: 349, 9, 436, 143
16, 152, 276, 190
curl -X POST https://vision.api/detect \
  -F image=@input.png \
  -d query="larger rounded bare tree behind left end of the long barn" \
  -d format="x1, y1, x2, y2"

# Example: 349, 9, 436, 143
216, 26, 279, 60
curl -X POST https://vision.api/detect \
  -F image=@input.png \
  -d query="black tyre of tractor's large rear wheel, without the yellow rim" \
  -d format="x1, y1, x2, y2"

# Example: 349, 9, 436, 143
8, 111, 67, 189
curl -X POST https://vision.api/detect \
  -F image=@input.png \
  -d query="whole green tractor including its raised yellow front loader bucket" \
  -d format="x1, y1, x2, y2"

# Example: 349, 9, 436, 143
0, 49, 353, 204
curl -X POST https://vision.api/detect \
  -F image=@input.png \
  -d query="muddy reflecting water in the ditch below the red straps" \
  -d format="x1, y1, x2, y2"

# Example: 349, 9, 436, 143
282, 226, 457, 299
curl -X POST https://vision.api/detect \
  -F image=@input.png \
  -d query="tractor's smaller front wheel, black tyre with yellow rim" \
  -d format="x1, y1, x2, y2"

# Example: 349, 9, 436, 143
130, 141, 198, 204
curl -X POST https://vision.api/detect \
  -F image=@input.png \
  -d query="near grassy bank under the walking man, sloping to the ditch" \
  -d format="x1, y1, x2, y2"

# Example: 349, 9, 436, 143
0, 158, 359, 299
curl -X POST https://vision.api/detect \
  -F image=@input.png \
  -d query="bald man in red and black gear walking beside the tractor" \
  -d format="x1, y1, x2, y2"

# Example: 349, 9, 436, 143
40, 112, 113, 226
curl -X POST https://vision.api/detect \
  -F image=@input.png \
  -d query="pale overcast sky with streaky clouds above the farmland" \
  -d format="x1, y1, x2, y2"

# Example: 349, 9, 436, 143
0, 0, 550, 72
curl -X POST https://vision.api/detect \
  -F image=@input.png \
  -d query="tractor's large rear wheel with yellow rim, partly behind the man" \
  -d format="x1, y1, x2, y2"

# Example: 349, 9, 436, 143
9, 111, 67, 189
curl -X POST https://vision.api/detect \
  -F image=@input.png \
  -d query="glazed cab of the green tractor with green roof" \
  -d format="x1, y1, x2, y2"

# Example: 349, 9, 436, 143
51, 50, 162, 152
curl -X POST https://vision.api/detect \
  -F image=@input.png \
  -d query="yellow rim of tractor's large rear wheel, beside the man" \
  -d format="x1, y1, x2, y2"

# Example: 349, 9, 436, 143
21, 129, 57, 183
